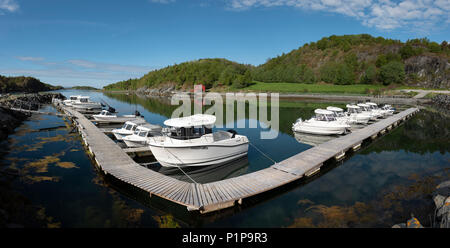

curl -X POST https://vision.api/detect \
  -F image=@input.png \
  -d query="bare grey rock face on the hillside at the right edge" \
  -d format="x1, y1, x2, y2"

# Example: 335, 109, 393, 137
405, 55, 450, 89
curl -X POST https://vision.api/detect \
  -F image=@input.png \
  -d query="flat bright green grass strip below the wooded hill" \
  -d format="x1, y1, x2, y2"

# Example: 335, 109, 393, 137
234, 82, 384, 95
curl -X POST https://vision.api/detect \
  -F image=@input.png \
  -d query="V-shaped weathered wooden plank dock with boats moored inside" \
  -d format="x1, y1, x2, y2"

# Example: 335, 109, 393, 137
62, 104, 419, 213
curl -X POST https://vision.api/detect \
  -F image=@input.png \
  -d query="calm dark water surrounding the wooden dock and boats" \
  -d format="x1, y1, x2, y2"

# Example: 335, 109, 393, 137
0, 91, 450, 227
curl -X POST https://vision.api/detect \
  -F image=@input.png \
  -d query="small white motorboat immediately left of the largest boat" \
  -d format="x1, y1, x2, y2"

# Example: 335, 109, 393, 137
123, 124, 162, 148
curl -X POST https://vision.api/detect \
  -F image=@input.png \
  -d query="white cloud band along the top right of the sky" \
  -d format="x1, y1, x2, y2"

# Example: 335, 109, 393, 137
228, 0, 450, 30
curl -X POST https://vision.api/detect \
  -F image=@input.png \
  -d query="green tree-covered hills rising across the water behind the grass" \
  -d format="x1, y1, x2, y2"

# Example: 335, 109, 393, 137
104, 34, 450, 90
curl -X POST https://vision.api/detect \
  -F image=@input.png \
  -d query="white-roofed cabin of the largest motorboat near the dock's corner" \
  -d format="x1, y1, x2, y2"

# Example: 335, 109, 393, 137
164, 114, 216, 140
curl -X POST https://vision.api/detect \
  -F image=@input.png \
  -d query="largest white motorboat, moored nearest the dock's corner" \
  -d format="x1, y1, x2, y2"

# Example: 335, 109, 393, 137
149, 114, 249, 167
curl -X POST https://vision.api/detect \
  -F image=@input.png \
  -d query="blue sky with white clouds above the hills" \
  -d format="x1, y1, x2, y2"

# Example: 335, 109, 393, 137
0, 0, 450, 87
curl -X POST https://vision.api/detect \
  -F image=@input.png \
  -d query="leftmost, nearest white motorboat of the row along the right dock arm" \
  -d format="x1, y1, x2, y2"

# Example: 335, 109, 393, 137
292, 109, 350, 135
